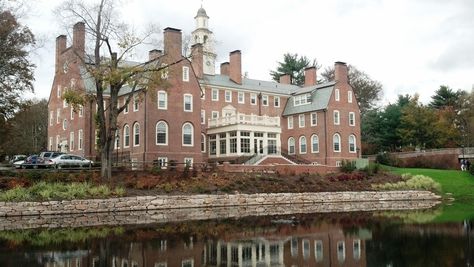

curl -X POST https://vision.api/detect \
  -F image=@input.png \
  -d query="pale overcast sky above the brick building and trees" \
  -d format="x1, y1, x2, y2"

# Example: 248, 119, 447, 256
24, 0, 474, 104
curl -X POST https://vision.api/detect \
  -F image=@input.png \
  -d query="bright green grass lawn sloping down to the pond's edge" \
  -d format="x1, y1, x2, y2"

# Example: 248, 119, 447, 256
389, 167, 474, 222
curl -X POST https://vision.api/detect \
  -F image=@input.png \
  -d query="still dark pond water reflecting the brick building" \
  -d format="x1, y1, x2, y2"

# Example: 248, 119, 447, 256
0, 211, 474, 267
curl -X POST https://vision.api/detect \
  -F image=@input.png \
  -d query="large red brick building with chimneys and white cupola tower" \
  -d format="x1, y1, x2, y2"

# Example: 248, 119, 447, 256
48, 7, 360, 166
